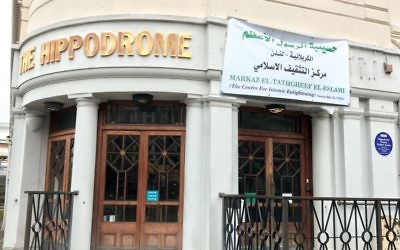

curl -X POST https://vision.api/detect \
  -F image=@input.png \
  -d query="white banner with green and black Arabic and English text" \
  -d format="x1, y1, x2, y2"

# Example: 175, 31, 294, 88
222, 19, 350, 105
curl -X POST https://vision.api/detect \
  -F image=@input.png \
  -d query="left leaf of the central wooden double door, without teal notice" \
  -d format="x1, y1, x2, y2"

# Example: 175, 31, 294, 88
97, 131, 143, 249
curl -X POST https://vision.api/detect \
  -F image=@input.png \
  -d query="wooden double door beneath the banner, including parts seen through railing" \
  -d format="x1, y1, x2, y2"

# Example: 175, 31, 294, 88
239, 136, 311, 247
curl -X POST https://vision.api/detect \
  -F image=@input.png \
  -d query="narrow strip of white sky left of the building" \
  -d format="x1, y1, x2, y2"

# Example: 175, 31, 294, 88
0, 0, 12, 123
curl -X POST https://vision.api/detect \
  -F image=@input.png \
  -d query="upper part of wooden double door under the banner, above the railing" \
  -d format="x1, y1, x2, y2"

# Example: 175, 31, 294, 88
239, 136, 307, 196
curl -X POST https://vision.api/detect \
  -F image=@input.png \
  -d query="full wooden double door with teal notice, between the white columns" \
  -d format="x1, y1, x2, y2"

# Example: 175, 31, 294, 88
95, 131, 184, 249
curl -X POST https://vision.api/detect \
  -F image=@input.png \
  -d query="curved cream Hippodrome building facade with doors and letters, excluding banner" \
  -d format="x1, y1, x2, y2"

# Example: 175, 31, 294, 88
3, 0, 400, 250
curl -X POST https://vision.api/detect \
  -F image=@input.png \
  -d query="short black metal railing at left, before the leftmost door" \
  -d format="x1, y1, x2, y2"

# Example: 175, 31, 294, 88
24, 191, 78, 250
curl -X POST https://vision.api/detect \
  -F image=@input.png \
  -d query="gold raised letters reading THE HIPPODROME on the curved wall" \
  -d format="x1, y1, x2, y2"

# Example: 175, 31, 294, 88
19, 31, 192, 75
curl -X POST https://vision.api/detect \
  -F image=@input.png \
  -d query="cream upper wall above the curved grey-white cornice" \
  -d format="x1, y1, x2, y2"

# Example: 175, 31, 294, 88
21, 0, 400, 48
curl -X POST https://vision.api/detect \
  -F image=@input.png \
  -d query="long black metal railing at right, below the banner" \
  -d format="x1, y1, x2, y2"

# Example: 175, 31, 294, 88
220, 194, 400, 250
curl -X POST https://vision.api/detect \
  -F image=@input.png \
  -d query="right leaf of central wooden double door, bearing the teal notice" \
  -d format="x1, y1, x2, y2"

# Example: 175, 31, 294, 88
141, 132, 184, 249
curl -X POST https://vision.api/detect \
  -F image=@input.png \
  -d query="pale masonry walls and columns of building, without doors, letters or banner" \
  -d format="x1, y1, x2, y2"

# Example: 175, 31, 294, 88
7, 0, 400, 250
